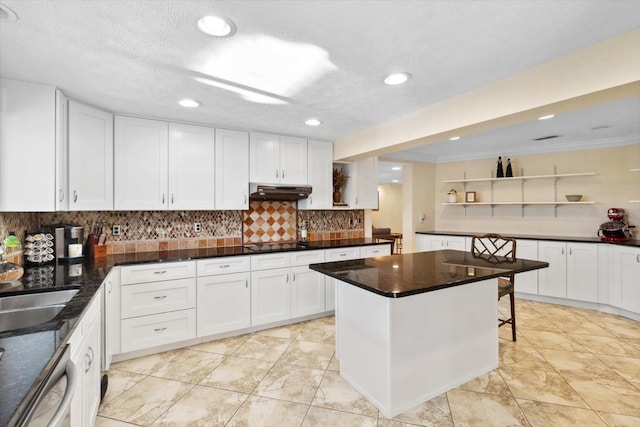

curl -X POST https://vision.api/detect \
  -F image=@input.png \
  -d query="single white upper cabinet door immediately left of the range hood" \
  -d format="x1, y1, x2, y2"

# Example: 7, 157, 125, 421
215, 129, 249, 210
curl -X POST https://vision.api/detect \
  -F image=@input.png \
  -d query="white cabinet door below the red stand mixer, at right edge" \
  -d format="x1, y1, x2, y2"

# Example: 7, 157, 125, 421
610, 245, 640, 314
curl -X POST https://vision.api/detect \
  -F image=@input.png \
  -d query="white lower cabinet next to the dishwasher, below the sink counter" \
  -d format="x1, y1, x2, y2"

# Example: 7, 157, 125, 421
69, 290, 102, 427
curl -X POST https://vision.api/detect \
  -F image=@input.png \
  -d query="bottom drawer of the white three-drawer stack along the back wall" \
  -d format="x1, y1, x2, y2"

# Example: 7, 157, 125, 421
122, 308, 196, 352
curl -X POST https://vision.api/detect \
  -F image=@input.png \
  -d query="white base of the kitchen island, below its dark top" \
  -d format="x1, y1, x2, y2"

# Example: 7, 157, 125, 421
336, 279, 498, 417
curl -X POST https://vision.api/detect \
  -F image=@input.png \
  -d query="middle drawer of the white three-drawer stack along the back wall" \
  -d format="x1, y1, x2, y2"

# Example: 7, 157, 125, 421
121, 278, 196, 319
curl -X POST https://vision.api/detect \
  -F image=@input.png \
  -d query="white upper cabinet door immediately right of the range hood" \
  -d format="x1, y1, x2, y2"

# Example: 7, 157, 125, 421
298, 140, 333, 209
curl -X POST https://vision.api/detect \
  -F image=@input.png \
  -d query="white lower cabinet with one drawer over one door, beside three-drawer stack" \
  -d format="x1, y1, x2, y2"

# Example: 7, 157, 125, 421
197, 256, 251, 337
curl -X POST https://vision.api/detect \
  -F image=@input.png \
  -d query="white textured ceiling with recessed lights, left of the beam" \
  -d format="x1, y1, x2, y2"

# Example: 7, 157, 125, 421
0, 0, 640, 155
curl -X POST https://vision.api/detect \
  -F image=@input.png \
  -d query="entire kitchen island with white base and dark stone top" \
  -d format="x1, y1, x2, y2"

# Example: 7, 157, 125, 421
309, 250, 549, 417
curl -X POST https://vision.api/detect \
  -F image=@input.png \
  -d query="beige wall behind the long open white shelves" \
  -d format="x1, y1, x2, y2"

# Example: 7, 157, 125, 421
434, 141, 640, 238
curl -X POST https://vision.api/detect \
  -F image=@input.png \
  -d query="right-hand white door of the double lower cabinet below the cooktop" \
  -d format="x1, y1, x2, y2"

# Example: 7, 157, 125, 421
291, 266, 325, 317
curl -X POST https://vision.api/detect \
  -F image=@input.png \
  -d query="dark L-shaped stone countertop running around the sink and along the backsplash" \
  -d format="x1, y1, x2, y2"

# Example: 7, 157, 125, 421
0, 238, 391, 426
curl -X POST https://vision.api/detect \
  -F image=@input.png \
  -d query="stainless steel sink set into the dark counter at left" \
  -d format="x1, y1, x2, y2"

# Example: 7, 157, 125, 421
0, 289, 78, 332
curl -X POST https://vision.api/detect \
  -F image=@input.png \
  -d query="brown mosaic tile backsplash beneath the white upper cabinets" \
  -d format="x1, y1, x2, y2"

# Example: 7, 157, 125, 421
0, 202, 364, 254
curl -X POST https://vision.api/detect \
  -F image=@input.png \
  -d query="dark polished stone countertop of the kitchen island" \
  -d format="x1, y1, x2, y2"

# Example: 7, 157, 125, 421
309, 250, 549, 298
